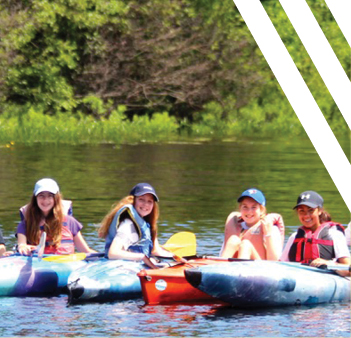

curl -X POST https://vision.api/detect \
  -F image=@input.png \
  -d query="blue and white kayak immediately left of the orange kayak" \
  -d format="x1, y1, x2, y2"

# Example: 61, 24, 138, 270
67, 258, 147, 304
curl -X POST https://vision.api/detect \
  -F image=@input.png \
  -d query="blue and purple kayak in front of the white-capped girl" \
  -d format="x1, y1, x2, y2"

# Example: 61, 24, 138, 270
0, 255, 87, 297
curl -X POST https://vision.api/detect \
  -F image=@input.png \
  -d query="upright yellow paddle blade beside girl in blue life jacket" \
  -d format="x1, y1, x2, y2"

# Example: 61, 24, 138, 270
163, 231, 196, 257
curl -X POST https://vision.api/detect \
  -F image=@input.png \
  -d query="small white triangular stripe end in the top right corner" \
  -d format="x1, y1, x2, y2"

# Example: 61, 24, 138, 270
325, 0, 351, 47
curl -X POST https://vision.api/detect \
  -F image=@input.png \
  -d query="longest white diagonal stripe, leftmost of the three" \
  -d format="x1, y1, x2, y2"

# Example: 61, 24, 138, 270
233, 0, 351, 212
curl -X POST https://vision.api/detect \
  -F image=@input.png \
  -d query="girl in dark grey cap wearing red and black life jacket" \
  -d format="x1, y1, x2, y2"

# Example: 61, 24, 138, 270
280, 190, 350, 266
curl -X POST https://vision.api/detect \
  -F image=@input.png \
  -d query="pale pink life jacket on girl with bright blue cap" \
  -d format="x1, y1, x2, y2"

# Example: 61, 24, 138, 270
234, 212, 285, 260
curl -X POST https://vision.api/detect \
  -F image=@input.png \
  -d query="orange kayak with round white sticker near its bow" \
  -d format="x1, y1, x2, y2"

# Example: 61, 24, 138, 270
138, 258, 228, 305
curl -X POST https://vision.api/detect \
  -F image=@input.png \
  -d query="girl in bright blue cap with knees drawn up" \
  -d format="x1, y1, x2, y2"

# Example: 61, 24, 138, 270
220, 188, 284, 261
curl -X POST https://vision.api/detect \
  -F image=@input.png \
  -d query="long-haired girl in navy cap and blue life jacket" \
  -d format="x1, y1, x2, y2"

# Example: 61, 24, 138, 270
99, 183, 173, 268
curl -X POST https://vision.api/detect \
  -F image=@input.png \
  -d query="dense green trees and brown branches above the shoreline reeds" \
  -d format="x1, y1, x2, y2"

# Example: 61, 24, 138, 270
0, 0, 350, 143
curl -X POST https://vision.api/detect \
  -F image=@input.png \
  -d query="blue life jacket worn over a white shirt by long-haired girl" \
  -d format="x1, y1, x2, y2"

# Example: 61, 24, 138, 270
105, 204, 153, 257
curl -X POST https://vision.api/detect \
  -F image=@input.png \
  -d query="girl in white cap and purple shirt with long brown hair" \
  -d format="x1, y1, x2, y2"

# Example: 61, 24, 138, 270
17, 178, 96, 255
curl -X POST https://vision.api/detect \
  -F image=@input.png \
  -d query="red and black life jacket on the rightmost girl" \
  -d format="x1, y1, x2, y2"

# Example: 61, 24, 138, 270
289, 222, 344, 264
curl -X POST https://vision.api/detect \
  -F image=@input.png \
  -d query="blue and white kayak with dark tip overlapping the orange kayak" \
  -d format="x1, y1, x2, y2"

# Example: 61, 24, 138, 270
185, 261, 350, 308
